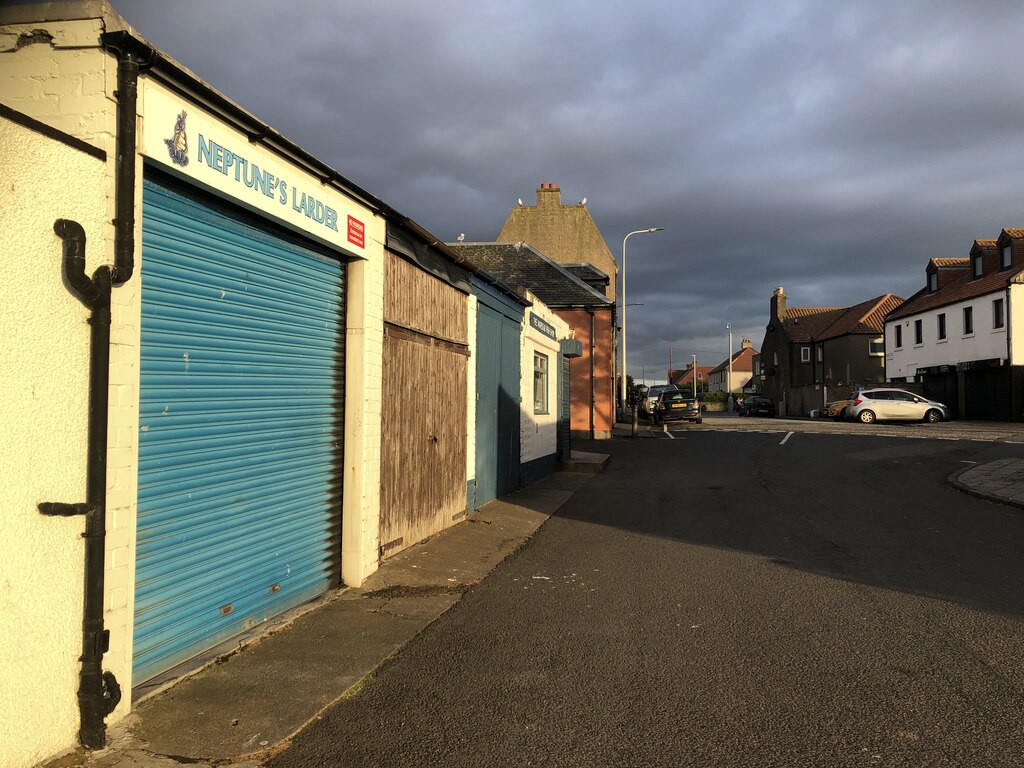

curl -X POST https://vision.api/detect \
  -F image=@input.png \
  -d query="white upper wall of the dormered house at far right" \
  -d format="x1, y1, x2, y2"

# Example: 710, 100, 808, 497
886, 291, 1012, 380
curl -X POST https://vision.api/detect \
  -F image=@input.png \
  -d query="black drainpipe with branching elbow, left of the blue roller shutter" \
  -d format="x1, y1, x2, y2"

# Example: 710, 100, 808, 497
39, 33, 149, 750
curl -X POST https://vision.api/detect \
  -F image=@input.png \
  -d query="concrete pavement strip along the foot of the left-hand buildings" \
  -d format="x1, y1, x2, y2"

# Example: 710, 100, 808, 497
46, 451, 608, 768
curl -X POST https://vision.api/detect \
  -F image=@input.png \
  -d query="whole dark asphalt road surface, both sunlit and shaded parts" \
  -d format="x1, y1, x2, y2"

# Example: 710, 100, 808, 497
269, 434, 1024, 768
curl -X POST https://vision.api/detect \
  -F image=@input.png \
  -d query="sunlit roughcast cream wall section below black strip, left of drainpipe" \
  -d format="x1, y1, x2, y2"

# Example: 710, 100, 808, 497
0, 111, 106, 768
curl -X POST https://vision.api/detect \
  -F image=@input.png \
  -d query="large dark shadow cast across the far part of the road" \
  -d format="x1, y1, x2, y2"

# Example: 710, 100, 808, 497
558, 431, 1024, 616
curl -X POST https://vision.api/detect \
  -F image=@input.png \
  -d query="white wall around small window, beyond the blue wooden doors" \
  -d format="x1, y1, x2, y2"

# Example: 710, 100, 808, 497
519, 292, 569, 464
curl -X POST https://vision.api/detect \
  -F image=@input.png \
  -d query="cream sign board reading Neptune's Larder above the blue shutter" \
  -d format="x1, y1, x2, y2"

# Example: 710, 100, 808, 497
140, 79, 384, 255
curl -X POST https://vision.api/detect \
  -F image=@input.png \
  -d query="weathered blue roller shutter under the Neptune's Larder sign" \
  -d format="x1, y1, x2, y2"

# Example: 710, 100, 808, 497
133, 178, 344, 684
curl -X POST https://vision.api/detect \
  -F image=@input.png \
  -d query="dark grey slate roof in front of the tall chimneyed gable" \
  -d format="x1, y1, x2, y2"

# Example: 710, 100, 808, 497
446, 242, 615, 308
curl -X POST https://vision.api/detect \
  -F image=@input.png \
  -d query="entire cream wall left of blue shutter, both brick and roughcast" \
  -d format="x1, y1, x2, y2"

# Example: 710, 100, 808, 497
0, 13, 125, 766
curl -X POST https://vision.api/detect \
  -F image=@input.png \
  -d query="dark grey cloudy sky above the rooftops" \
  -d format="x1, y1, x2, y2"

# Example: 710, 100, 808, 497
114, 0, 1024, 381
